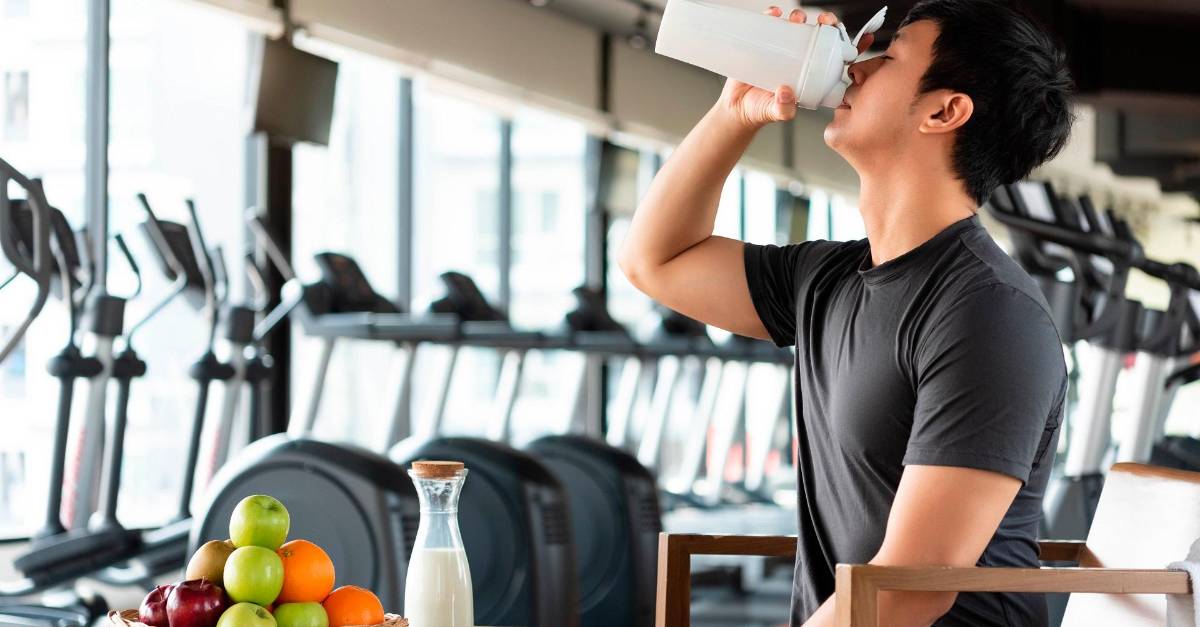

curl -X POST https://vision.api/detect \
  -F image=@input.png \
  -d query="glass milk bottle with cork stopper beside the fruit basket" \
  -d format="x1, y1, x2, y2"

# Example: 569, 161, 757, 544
404, 461, 475, 627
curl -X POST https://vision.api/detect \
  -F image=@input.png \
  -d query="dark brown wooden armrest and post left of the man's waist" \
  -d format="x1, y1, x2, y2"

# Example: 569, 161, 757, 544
654, 533, 796, 627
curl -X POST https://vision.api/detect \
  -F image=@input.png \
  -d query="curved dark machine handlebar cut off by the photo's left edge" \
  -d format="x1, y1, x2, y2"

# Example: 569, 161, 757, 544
0, 159, 53, 363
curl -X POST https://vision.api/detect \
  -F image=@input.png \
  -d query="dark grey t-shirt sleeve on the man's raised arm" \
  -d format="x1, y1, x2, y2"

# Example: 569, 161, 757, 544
744, 241, 829, 346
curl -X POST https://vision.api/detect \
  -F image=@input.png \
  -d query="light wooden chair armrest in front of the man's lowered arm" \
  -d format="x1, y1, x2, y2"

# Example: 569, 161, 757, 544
835, 565, 1192, 627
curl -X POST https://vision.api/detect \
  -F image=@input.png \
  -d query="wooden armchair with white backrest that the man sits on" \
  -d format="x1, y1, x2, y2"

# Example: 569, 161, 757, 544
656, 464, 1200, 627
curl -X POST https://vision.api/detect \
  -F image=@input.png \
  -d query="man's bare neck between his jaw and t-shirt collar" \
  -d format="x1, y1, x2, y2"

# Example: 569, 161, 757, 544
858, 167, 978, 267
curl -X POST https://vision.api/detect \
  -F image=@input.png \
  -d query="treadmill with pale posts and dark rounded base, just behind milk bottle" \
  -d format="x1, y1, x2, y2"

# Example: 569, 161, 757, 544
389, 271, 580, 627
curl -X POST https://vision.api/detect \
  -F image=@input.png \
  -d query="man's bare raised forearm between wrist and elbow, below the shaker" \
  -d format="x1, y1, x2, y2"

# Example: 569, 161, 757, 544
620, 103, 756, 274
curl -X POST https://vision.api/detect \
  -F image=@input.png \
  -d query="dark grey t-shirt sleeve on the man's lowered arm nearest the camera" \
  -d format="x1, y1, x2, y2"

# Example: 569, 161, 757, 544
904, 285, 1067, 482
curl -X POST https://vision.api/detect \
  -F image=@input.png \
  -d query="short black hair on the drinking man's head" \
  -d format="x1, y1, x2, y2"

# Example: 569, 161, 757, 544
901, 0, 1073, 204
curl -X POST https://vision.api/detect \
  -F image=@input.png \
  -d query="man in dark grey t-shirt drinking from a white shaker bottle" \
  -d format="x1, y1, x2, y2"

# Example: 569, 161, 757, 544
620, 0, 1072, 626
